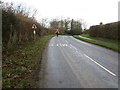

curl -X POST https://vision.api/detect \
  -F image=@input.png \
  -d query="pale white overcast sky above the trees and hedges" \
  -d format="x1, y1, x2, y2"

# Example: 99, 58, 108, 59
3, 0, 119, 27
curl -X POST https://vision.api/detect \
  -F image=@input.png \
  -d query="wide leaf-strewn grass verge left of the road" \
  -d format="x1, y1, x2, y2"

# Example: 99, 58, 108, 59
2, 35, 53, 88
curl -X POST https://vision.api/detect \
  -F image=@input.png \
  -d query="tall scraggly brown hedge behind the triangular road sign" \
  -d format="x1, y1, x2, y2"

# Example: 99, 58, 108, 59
2, 3, 53, 47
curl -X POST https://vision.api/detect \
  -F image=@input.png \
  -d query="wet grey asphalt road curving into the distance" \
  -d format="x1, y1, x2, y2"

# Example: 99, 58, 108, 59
41, 36, 118, 88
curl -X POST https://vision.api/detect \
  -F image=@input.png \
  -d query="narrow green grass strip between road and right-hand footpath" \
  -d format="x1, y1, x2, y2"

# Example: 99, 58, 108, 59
73, 35, 120, 52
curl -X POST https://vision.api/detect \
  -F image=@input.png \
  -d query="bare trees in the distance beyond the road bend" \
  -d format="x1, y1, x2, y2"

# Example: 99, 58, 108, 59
50, 19, 82, 35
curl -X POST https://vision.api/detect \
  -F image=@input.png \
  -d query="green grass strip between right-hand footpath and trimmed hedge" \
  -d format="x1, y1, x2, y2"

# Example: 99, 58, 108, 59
81, 34, 120, 44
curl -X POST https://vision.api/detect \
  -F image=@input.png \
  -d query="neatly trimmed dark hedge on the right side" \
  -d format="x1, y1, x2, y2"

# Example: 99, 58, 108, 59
89, 22, 120, 40
